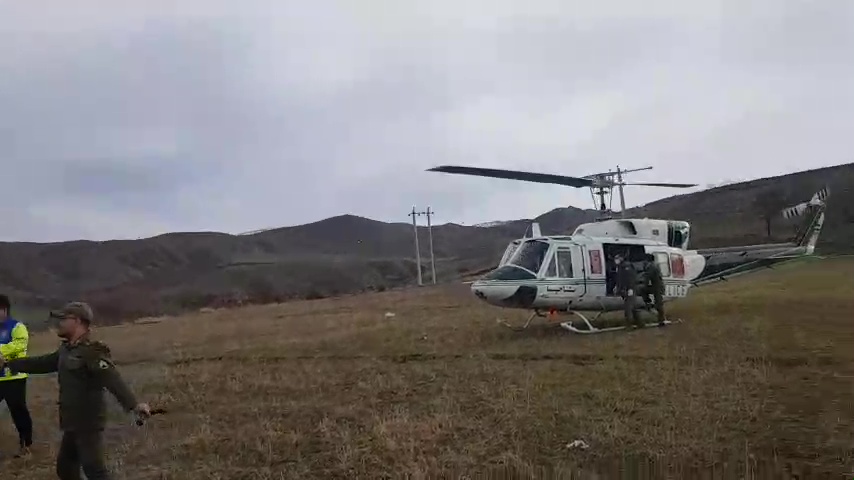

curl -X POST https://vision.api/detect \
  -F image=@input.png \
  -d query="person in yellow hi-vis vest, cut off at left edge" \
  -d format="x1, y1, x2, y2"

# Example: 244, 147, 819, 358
0, 295, 33, 457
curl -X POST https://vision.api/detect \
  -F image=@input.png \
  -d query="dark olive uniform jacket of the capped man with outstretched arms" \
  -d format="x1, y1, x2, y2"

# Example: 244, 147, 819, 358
8, 336, 137, 431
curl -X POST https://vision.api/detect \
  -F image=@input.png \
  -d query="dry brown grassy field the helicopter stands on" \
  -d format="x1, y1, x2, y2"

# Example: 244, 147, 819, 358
0, 259, 854, 480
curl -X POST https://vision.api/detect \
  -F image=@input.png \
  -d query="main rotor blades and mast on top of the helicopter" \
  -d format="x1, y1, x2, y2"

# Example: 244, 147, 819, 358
427, 165, 697, 220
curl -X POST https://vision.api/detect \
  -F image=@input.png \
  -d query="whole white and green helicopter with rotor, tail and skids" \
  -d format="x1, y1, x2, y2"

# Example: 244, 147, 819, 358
428, 165, 829, 334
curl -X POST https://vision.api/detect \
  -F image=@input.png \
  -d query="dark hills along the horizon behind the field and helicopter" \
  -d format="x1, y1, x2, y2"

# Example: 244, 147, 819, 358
0, 164, 854, 321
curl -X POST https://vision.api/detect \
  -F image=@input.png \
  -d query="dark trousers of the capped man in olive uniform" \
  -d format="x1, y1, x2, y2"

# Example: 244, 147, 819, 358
56, 430, 111, 480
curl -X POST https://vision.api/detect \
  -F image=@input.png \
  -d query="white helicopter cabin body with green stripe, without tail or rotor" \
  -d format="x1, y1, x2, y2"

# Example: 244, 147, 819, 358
471, 219, 705, 312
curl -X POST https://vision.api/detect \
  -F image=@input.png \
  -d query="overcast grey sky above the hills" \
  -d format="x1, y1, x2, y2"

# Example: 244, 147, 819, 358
0, 0, 854, 241
